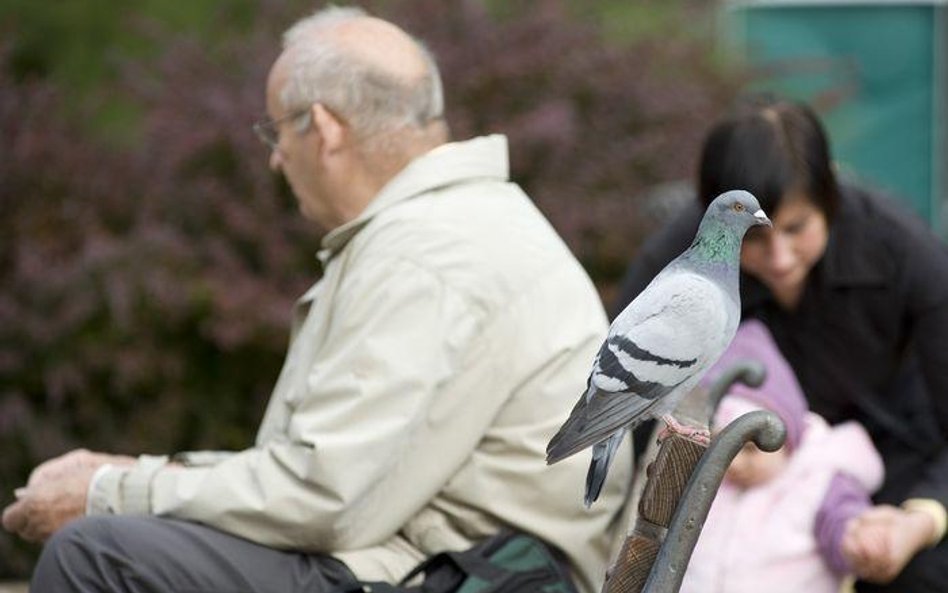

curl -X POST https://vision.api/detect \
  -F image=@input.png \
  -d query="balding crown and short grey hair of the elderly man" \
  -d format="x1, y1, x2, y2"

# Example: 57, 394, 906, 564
274, 7, 444, 148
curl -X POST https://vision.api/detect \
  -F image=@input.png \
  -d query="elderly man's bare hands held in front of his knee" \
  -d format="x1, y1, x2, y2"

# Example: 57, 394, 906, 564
3, 449, 135, 542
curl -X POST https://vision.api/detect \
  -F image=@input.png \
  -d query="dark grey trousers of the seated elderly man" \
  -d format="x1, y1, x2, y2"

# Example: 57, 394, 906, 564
30, 516, 354, 593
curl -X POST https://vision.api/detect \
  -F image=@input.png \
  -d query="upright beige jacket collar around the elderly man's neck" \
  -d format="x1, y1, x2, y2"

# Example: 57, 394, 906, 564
317, 134, 510, 265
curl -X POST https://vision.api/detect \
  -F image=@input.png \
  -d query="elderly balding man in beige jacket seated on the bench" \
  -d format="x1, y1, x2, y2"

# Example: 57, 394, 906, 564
3, 8, 631, 593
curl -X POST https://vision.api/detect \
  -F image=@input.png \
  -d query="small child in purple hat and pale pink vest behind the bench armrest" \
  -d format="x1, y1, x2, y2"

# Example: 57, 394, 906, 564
681, 320, 883, 593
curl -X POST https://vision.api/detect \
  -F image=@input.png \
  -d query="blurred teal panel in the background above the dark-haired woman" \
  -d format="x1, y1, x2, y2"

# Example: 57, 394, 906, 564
730, 3, 944, 226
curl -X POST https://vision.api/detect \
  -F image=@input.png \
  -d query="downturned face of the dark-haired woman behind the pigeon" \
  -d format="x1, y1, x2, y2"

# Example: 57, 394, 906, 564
741, 194, 829, 308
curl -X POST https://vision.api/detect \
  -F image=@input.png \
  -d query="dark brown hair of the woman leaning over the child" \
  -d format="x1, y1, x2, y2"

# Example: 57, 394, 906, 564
698, 97, 839, 221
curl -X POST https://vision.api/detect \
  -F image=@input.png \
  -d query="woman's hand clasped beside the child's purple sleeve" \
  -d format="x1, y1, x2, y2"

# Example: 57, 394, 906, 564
842, 505, 935, 584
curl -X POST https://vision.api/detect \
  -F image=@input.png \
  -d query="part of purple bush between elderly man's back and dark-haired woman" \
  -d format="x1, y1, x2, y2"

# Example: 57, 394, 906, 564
388, 1, 737, 286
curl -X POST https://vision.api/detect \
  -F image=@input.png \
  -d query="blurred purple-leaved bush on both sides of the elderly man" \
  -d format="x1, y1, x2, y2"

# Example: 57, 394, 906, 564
0, 0, 734, 579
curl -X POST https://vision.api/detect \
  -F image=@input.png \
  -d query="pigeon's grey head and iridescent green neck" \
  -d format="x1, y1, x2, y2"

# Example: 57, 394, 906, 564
689, 190, 773, 264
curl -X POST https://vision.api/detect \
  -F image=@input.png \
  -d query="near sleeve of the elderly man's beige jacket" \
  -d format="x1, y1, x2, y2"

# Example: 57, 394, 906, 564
87, 258, 496, 552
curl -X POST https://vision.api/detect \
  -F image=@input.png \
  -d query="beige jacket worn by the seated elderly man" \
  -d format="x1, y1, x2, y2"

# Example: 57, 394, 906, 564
90, 136, 631, 593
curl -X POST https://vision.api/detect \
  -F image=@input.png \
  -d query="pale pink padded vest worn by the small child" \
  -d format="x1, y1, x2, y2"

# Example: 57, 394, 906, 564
681, 413, 883, 593
